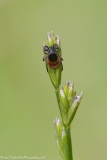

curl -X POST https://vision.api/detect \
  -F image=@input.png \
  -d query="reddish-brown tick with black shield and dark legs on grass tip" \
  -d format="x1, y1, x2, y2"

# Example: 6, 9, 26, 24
43, 44, 63, 72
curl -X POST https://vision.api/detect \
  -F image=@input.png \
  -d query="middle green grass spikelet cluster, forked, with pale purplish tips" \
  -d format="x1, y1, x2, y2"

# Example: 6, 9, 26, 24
59, 81, 83, 126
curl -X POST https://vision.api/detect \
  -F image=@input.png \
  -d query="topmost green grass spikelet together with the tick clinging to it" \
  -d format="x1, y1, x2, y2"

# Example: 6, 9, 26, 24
43, 31, 63, 89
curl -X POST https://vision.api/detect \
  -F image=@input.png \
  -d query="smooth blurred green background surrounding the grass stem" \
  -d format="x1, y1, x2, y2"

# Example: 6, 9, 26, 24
0, 0, 107, 160
